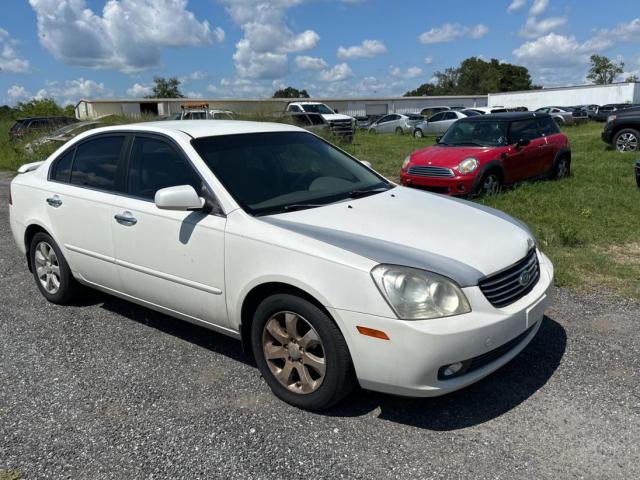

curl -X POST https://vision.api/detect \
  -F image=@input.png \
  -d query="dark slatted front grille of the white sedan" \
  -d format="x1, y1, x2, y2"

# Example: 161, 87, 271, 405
478, 249, 540, 308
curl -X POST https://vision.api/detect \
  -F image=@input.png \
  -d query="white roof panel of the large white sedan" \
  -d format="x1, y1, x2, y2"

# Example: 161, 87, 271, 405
79, 120, 306, 138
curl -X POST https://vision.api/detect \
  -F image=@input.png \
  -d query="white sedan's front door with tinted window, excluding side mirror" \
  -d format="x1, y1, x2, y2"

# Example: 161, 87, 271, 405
111, 134, 228, 327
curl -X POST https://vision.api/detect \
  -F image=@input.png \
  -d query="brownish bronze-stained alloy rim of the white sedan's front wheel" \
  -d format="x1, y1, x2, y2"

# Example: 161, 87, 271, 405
262, 311, 326, 394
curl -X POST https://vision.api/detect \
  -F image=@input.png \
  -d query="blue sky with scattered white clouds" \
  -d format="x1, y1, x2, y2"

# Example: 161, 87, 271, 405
0, 0, 640, 104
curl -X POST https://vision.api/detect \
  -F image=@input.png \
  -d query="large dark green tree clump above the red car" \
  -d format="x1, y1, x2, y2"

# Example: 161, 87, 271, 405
405, 57, 540, 96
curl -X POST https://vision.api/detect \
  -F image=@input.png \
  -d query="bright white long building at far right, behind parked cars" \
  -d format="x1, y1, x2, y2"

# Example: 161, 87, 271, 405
489, 82, 640, 110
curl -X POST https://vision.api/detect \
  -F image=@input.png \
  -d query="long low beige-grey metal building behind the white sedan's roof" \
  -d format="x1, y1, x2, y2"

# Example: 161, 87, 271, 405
76, 95, 487, 120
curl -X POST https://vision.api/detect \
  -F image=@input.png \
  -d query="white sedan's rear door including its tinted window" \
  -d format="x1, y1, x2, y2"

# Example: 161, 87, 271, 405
43, 134, 126, 290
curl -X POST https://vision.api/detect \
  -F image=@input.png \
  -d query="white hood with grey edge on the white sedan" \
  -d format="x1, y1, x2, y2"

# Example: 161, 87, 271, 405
260, 187, 535, 287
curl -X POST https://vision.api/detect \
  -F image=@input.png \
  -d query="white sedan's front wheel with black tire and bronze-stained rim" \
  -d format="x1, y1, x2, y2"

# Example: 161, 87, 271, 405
251, 294, 356, 410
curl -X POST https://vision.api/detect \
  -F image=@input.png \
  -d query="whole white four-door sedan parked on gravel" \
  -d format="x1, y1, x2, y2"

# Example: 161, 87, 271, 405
9, 121, 553, 409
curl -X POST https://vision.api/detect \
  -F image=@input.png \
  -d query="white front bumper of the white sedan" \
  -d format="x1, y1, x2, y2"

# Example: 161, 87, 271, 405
330, 253, 553, 397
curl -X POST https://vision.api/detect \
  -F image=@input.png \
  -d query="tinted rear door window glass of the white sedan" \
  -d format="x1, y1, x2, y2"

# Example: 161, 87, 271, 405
71, 136, 124, 190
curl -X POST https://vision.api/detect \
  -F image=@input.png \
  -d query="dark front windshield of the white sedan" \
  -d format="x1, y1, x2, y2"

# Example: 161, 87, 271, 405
192, 132, 393, 215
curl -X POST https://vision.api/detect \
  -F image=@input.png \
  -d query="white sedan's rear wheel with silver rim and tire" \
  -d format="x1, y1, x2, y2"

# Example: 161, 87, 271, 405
29, 232, 78, 305
